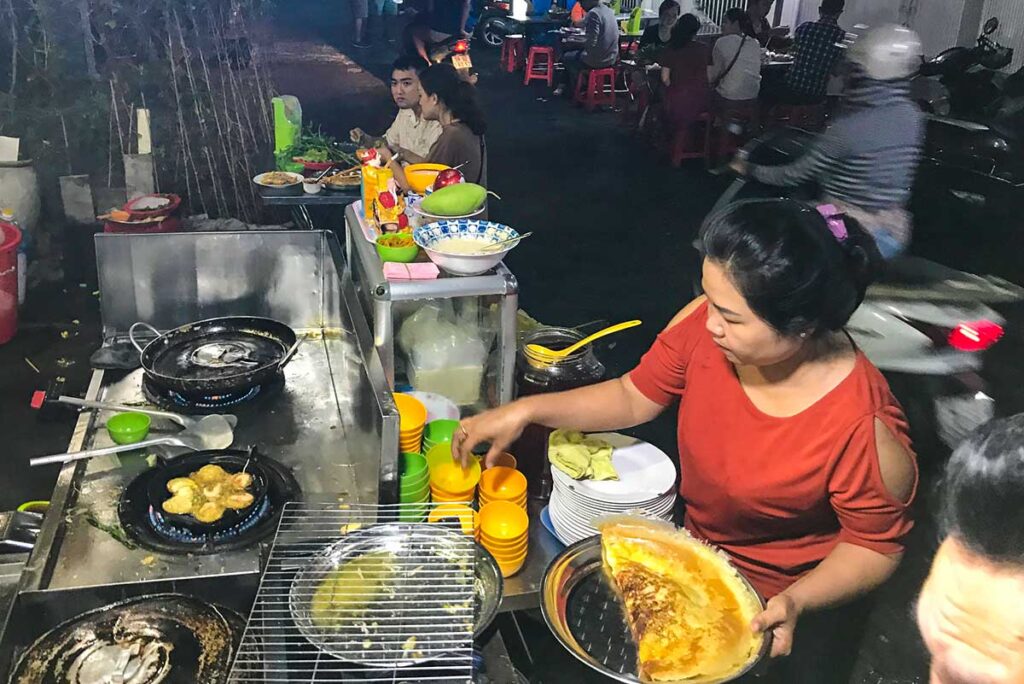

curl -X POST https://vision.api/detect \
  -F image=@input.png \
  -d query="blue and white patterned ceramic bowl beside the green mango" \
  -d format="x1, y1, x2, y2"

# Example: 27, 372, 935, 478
413, 218, 519, 275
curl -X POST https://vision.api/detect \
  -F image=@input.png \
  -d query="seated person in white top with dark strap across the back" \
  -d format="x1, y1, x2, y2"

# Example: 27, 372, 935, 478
708, 7, 761, 106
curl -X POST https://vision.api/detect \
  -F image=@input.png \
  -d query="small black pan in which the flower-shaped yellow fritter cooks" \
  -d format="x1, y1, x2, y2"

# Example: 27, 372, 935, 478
146, 451, 266, 535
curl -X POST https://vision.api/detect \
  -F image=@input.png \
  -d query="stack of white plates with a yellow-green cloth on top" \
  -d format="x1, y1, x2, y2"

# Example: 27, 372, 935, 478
548, 433, 676, 544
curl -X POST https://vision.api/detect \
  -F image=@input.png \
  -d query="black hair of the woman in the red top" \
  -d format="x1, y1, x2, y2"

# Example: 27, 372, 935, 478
700, 200, 882, 336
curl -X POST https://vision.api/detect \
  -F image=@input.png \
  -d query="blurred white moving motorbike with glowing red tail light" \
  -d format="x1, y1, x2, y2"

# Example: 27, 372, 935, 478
695, 129, 1024, 454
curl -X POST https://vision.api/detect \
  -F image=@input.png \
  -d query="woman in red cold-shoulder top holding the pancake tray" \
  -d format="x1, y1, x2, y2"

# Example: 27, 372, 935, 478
454, 200, 918, 684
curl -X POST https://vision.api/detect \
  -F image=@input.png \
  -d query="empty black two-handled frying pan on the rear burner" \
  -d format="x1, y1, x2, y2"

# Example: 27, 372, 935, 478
128, 316, 298, 396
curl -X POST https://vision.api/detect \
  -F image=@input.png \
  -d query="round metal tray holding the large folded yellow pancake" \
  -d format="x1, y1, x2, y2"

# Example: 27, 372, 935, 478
541, 536, 770, 684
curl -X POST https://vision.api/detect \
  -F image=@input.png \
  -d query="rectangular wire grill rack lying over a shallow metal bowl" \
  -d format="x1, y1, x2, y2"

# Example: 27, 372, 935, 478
228, 501, 476, 684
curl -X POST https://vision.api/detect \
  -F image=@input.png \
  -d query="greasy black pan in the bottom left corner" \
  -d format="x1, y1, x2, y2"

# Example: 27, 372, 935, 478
9, 594, 240, 684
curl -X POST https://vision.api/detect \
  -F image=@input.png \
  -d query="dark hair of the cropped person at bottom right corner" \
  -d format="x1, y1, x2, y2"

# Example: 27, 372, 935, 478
939, 414, 1024, 565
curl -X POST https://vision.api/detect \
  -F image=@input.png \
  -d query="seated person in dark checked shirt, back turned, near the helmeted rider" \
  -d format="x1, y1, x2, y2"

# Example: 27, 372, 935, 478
768, 0, 846, 104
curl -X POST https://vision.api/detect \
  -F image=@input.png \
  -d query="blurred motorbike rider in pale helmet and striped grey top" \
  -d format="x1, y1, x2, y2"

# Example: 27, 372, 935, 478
732, 26, 925, 259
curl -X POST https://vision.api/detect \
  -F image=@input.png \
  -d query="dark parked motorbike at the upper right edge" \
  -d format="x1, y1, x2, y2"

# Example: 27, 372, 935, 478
913, 17, 1024, 218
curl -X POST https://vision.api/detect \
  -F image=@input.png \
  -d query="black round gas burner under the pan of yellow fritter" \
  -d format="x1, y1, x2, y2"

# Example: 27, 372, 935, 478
118, 451, 299, 554
